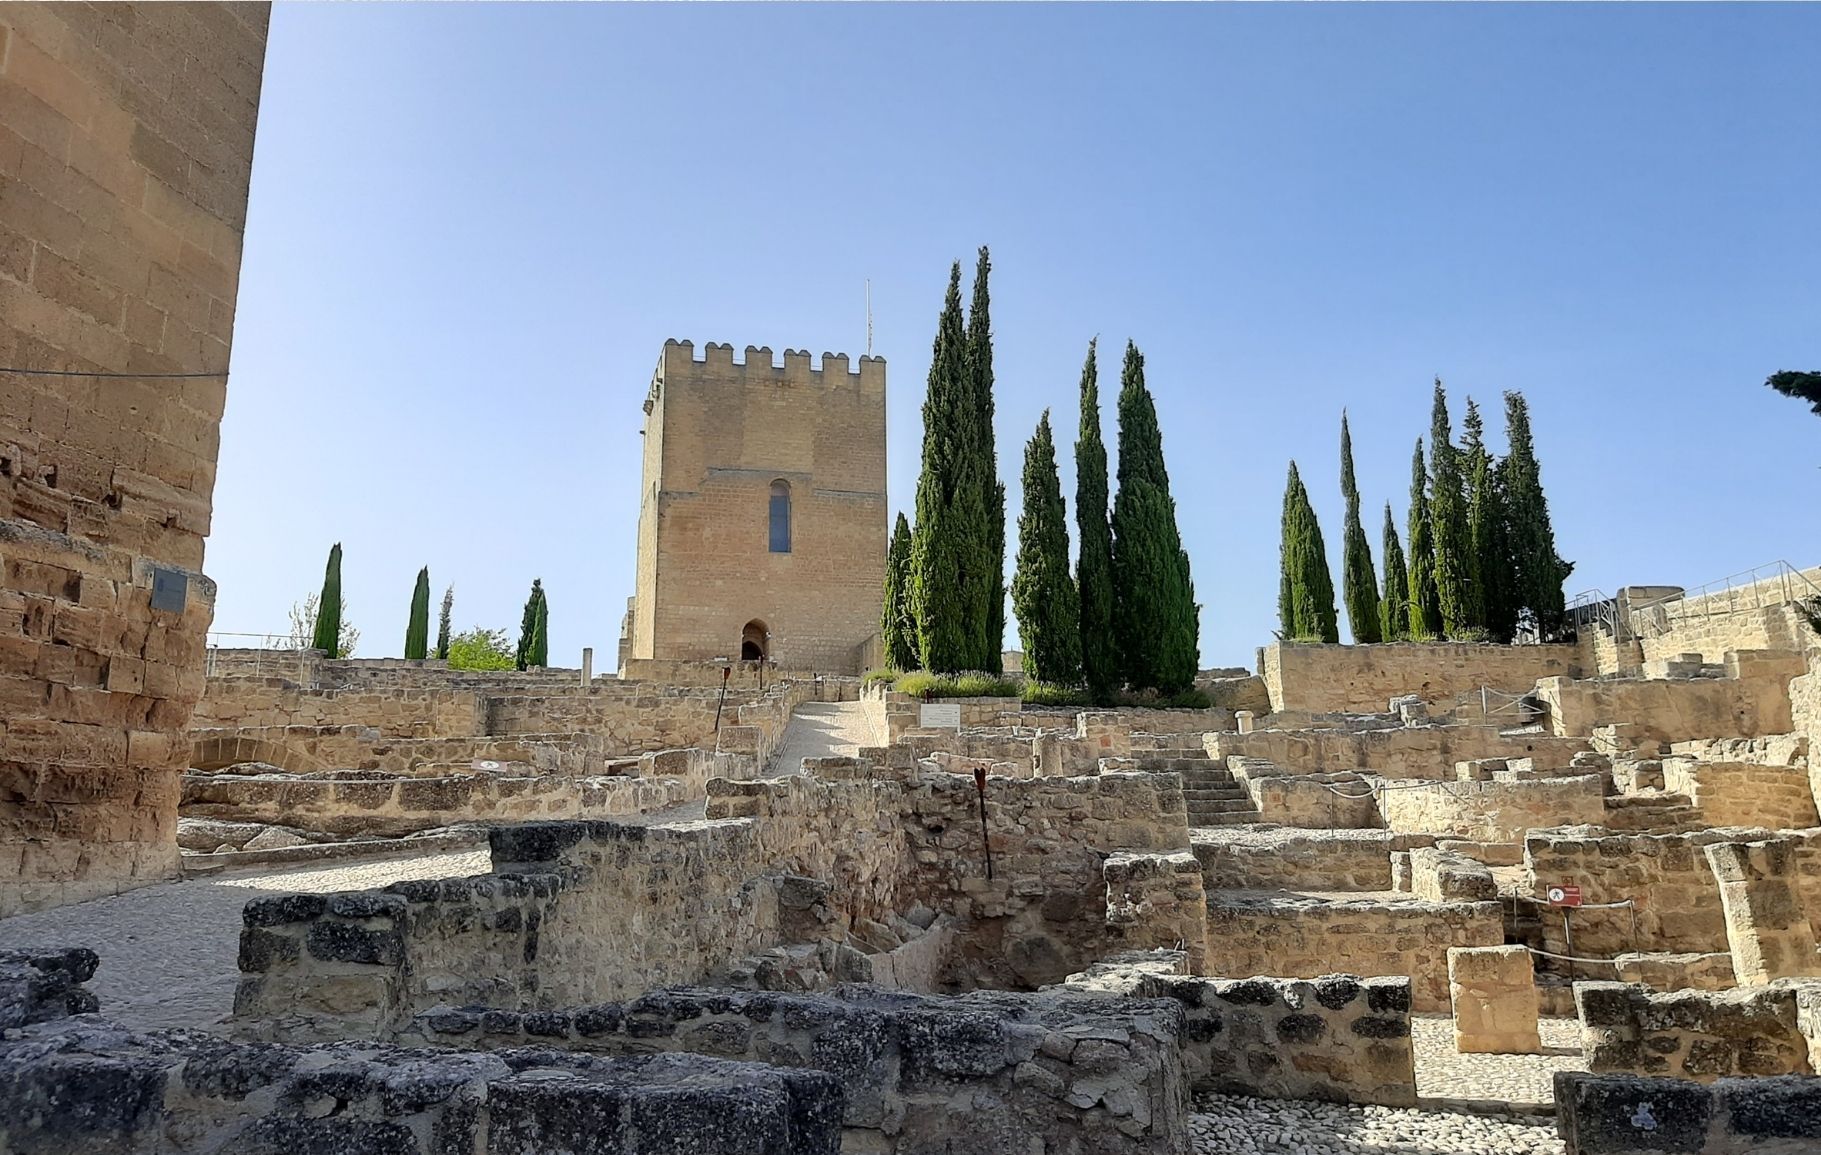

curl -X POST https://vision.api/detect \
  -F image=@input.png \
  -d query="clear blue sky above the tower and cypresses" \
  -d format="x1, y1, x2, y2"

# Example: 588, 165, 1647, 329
208, 4, 1821, 669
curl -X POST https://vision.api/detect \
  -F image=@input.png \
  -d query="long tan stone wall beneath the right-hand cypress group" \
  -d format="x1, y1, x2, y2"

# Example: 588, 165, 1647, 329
1258, 641, 1581, 714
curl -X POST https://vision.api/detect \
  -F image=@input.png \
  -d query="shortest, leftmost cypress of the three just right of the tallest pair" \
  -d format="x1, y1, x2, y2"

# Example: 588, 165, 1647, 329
1012, 410, 1082, 685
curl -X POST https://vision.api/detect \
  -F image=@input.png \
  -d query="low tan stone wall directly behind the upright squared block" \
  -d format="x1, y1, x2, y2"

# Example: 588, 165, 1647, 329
1207, 891, 1504, 1011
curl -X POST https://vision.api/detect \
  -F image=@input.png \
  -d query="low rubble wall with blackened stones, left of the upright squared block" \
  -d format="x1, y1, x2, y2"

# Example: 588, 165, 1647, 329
1067, 962, 1417, 1106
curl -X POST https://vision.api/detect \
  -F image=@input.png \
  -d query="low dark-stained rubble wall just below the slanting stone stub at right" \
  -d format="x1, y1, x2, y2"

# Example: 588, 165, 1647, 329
1575, 982, 1810, 1082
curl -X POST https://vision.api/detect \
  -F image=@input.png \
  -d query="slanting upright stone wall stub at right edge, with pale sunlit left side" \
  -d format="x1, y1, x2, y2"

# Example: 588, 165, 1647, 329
1706, 838, 1821, 987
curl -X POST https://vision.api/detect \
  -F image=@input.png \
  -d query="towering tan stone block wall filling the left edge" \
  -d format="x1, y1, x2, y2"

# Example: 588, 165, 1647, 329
0, 4, 266, 916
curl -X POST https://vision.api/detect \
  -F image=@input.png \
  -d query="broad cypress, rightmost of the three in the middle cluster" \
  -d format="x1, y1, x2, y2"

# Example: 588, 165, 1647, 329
1113, 342, 1200, 694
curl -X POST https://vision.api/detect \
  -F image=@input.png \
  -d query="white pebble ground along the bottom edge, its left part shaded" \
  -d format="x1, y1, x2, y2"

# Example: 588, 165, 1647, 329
1189, 1095, 1564, 1155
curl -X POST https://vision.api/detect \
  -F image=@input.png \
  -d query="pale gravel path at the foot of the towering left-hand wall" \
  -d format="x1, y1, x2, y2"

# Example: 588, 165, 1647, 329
0, 851, 490, 1029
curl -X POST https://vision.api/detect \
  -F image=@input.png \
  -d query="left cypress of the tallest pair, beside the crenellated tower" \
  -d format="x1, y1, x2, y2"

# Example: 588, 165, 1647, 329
911, 261, 983, 674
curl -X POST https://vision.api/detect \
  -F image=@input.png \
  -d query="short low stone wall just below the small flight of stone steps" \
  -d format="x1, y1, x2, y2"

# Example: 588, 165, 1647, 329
1191, 827, 1406, 891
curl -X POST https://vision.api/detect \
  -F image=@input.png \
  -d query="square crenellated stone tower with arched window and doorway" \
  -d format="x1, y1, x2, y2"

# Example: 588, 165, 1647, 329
623, 341, 889, 672
